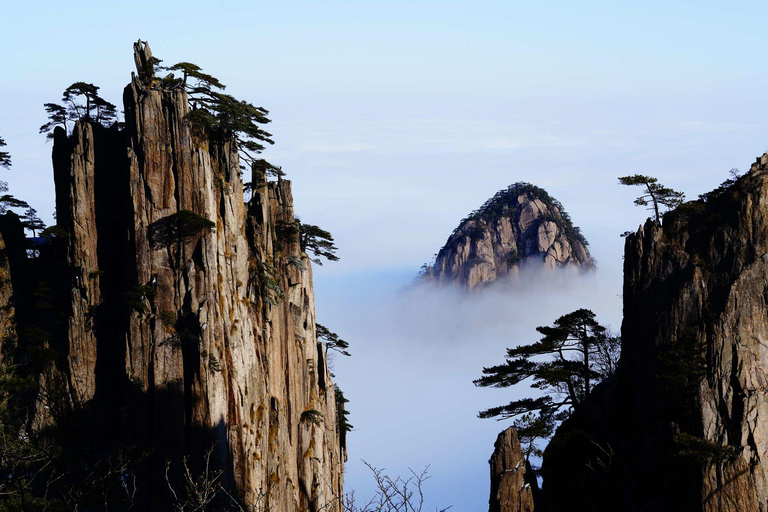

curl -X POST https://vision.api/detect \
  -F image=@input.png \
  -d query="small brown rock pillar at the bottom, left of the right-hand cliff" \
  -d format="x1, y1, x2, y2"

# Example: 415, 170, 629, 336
488, 427, 537, 512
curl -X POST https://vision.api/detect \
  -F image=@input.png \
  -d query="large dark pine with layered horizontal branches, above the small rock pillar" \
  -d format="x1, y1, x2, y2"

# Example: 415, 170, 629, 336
474, 309, 619, 455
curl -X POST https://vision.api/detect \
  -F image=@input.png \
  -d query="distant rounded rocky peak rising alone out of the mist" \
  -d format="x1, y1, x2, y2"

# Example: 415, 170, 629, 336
424, 183, 594, 290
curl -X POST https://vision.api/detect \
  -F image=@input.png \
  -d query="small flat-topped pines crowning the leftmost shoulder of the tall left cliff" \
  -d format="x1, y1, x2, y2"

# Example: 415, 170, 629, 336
40, 82, 117, 139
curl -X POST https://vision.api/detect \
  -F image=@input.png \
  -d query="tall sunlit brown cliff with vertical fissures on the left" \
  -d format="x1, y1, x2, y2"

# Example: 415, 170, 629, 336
30, 44, 345, 512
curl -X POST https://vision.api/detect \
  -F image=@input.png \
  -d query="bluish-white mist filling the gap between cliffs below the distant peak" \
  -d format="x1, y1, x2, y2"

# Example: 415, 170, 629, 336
316, 266, 621, 510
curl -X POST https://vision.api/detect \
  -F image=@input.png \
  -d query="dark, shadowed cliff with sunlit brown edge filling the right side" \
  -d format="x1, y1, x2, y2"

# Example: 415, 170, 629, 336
543, 154, 768, 512
